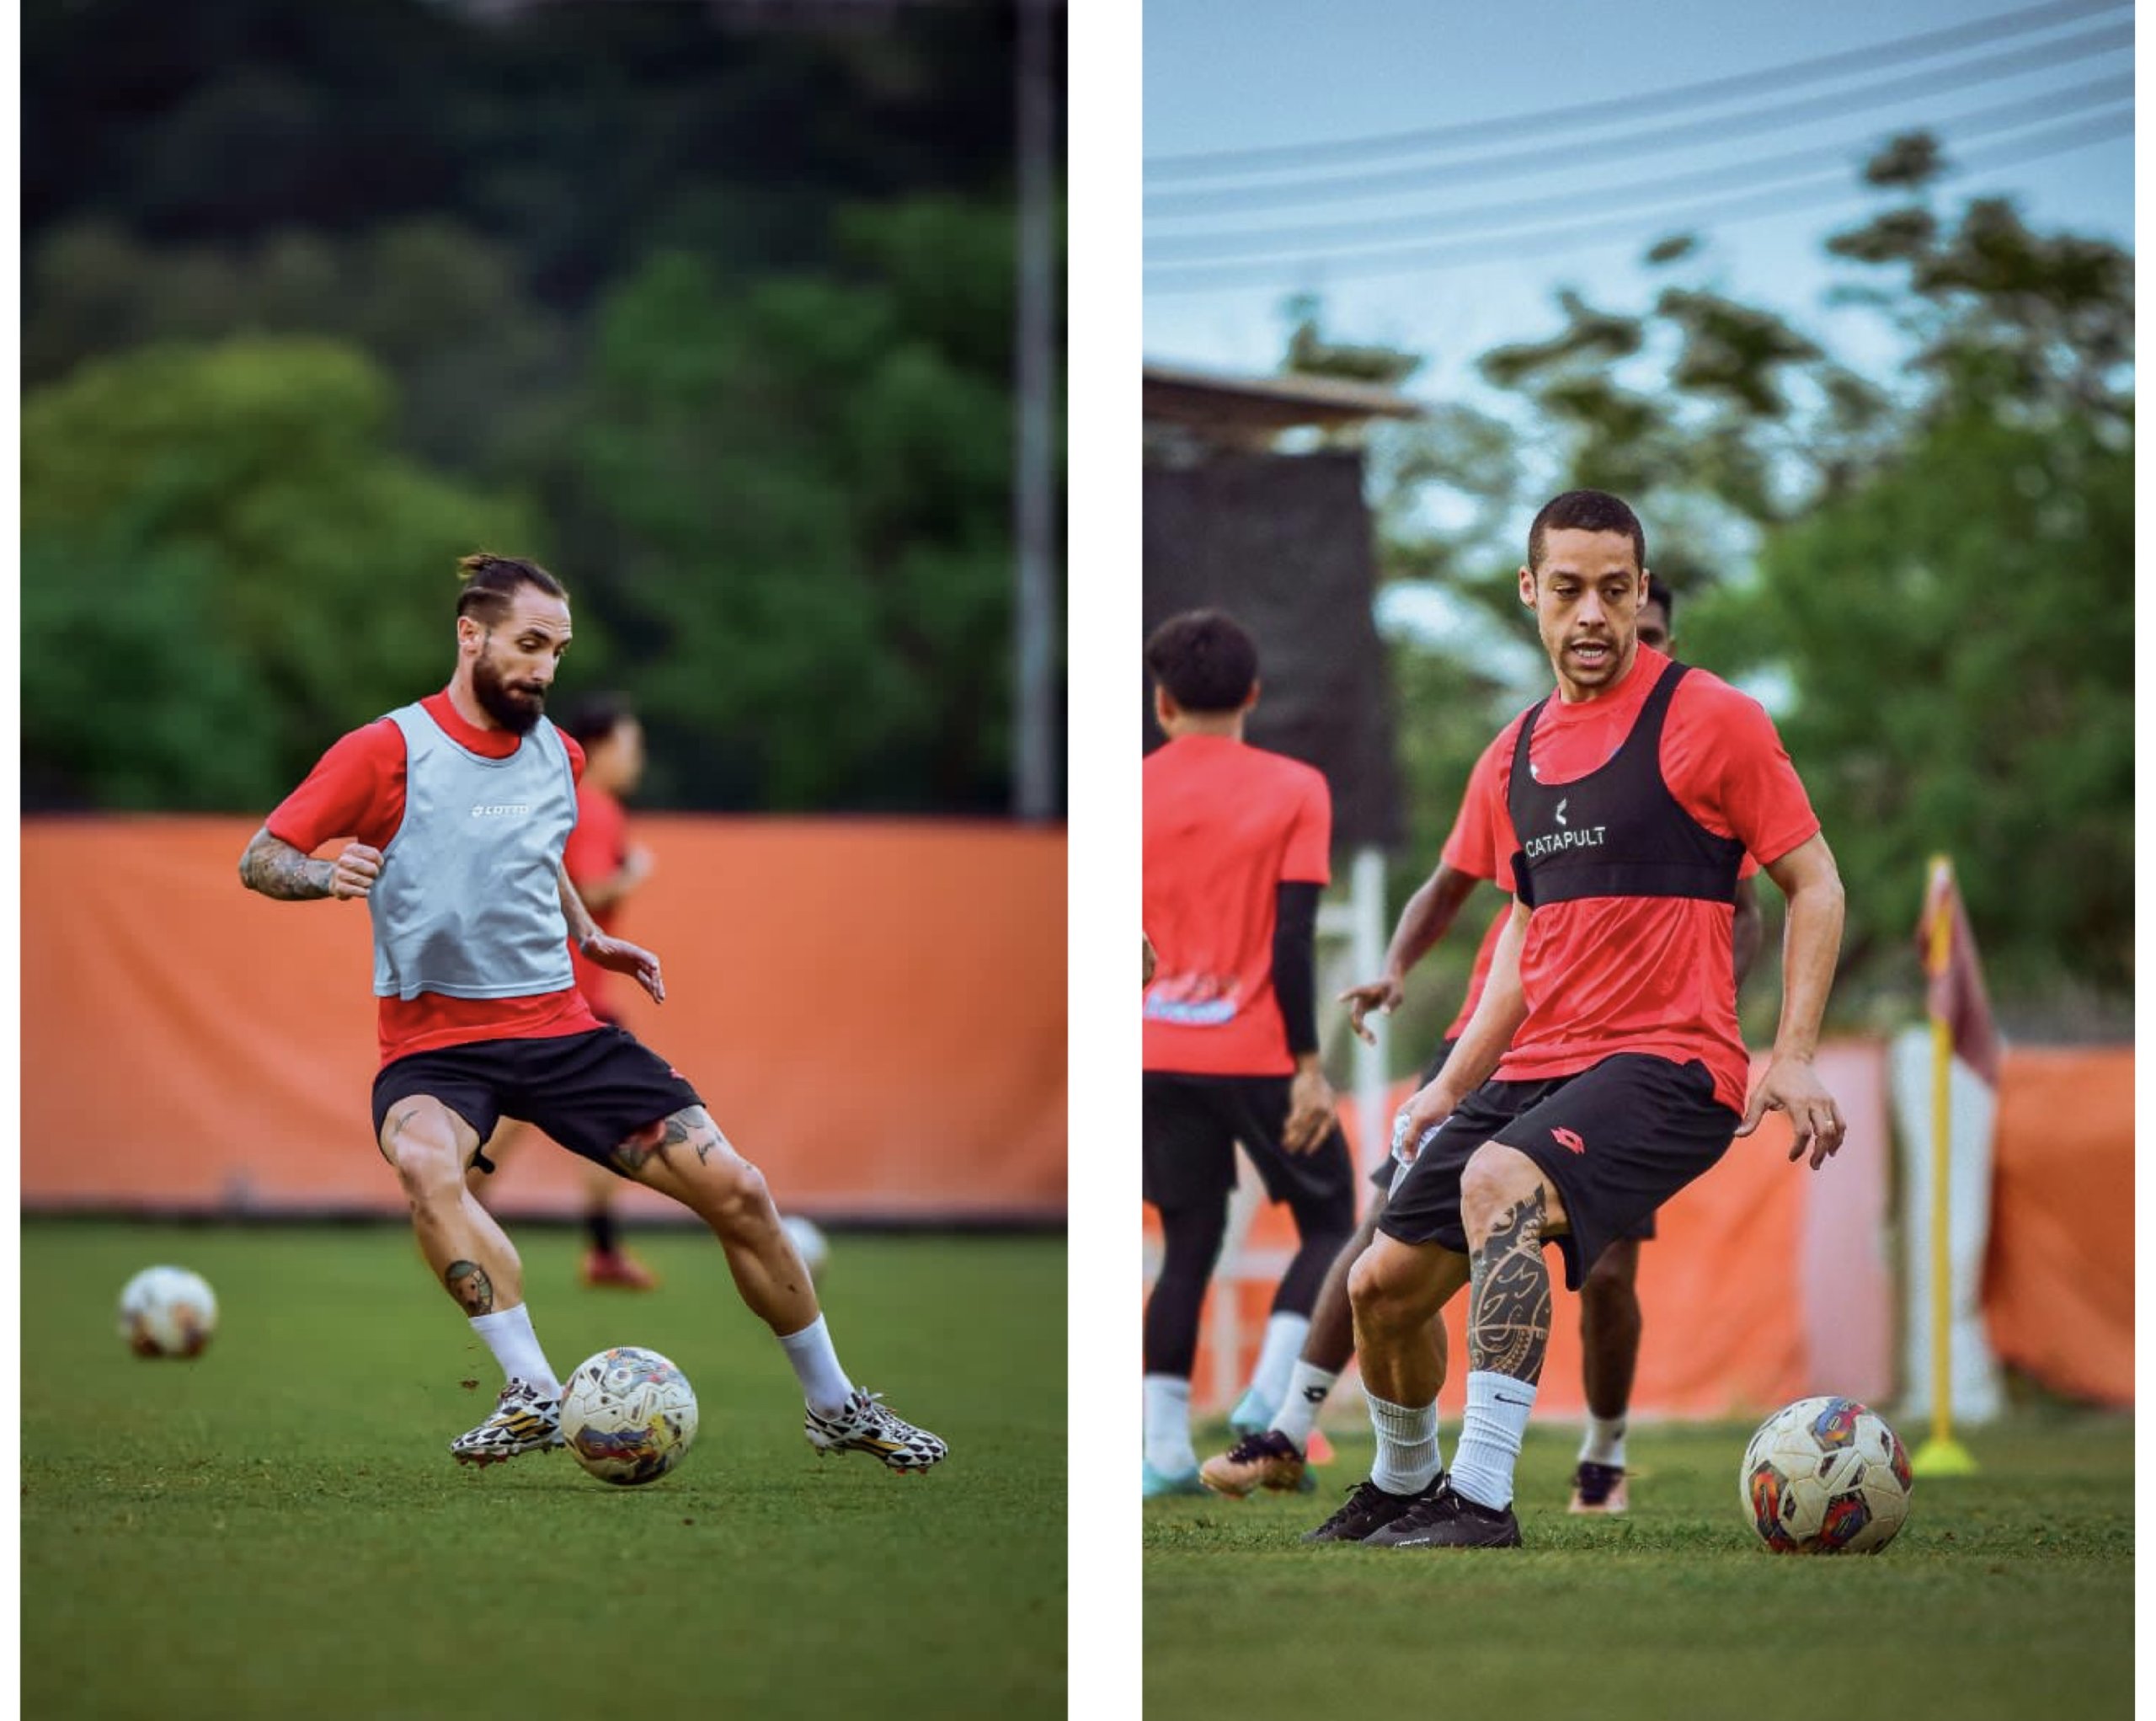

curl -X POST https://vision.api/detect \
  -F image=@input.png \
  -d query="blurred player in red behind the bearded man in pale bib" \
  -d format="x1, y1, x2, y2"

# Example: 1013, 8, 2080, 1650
470, 694, 658, 1290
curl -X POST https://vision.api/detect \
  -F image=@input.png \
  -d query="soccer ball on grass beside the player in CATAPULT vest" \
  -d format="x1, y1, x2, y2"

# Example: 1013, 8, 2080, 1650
1737, 1398, 1910, 1553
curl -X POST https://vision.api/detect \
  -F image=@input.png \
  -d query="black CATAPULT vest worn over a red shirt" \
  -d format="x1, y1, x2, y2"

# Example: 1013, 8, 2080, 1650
1505, 662, 1744, 908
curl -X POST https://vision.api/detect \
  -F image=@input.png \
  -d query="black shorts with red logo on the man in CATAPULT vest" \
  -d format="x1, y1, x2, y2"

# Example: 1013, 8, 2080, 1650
1378, 1052, 1740, 1290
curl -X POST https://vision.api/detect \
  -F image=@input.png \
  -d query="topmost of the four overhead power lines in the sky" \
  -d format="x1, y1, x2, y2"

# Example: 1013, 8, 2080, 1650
1145, 0, 2132, 181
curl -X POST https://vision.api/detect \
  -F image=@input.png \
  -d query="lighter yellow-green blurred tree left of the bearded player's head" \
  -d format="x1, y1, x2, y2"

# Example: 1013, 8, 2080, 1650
22, 339, 547, 811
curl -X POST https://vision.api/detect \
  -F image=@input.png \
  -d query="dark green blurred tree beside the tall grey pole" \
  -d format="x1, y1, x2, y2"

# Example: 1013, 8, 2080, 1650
561, 199, 1011, 813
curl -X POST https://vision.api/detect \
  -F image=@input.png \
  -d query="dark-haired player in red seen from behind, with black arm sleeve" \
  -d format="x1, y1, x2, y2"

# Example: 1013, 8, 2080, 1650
1143, 611, 1354, 1497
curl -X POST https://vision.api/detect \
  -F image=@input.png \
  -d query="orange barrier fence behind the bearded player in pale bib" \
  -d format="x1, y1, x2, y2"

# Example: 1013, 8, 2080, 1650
22, 815, 1067, 1221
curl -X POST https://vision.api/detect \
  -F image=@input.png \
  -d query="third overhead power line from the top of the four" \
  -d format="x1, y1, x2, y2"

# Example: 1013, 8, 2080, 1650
1145, 71, 2134, 263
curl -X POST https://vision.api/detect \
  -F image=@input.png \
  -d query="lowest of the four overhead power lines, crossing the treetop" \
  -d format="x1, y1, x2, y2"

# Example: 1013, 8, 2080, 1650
1145, 108, 2134, 293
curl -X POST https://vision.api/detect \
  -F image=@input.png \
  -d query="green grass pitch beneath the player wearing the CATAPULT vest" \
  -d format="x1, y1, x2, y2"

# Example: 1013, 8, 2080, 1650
1134, 1413, 2134, 1721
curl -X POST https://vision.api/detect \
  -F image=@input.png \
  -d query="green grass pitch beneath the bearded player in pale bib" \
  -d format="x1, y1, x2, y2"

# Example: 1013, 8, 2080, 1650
22, 1221, 1065, 1721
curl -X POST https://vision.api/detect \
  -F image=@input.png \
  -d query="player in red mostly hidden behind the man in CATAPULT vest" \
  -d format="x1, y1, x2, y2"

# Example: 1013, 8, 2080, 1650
1198, 574, 1759, 1514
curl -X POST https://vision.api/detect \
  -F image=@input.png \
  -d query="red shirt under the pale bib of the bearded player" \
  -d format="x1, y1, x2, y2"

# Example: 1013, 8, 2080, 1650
265, 690, 600, 1063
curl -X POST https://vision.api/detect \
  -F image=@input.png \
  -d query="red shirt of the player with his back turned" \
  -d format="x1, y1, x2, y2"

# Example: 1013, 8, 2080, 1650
1145, 735, 1332, 1077
